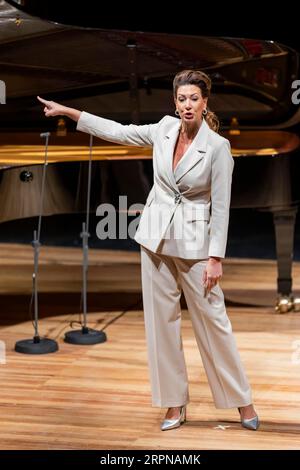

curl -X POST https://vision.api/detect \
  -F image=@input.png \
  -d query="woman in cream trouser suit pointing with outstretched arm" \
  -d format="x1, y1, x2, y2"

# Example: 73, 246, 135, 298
38, 70, 259, 430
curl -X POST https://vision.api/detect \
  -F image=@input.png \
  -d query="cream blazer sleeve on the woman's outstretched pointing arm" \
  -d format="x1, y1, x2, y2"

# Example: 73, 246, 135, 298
76, 111, 164, 147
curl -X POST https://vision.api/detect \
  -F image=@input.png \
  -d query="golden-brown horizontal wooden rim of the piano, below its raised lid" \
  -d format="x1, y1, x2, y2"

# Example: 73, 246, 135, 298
0, 131, 300, 170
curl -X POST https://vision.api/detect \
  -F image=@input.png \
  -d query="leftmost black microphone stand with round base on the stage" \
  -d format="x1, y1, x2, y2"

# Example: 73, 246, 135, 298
15, 132, 58, 354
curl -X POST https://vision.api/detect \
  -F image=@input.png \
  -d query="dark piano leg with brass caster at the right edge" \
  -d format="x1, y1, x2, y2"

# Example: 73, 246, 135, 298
272, 207, 299, 313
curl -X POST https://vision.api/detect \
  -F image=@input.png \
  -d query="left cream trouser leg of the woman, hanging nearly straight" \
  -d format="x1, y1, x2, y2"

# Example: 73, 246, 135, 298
141, 246, 189, 407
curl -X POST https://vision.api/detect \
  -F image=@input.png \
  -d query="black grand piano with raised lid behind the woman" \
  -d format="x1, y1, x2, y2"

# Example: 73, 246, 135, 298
0, 0, 300, 311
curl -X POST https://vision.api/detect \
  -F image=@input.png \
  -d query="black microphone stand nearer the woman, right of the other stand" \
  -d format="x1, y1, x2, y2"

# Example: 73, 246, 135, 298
64, 135, 107, 344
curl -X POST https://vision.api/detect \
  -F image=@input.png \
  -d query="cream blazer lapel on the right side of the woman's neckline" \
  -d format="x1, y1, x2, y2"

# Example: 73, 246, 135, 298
171, 119, 209, 183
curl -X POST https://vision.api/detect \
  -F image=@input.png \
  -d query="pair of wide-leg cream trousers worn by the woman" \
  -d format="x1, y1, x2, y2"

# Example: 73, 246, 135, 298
141, 246, 252, 408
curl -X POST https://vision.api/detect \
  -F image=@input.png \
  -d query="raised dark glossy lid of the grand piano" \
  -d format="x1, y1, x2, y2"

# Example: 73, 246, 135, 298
0, 0, 300, 130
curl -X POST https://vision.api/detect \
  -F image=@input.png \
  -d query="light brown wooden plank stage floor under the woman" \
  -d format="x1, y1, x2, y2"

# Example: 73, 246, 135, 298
0, 245, 300, 449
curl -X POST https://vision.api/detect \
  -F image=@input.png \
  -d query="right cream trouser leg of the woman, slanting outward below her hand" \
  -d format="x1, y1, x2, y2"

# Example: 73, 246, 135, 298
174, 258, 252, 408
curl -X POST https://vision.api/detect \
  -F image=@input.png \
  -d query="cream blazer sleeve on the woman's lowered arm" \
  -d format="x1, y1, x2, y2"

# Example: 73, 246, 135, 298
208, 139, 234, 258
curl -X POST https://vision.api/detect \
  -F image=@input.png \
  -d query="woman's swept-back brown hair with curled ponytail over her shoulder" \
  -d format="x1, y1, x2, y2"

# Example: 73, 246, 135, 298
173, 70, 220, 132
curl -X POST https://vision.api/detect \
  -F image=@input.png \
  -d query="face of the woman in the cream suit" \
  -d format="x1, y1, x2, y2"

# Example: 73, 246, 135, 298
175, 85, 207, 125
